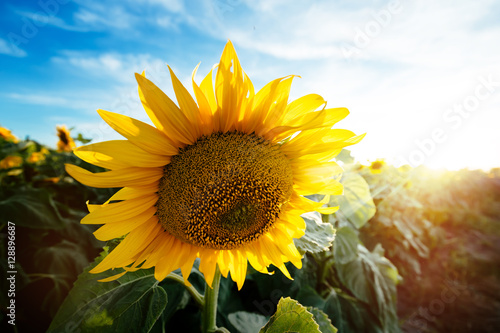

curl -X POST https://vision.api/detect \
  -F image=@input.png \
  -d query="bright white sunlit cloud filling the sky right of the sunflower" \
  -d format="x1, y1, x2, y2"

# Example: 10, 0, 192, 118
177, 0, 500, 167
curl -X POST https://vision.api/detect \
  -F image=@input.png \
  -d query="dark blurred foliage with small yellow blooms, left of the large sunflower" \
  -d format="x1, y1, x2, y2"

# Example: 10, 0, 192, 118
0, 134, 113, 332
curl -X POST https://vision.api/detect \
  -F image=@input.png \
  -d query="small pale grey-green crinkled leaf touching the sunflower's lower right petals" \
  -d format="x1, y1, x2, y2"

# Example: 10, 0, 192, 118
294, 212, 335, 253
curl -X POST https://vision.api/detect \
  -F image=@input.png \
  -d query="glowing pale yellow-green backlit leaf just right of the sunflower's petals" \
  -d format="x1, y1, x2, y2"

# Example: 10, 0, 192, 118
329, 172, 377, 229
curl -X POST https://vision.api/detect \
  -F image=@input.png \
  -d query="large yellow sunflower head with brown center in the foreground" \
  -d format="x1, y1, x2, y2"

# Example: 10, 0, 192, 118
66, 41, 363, 288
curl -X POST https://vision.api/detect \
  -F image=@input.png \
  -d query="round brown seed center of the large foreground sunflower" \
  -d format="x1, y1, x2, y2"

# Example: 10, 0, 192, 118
156, 131, 293, 250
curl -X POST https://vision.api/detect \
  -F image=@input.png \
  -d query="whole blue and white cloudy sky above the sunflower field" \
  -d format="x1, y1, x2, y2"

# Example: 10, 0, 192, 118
0, 0, 500, 169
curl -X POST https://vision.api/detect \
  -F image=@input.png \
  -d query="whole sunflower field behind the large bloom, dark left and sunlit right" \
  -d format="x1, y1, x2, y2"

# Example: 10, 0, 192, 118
0, 123, 500, 333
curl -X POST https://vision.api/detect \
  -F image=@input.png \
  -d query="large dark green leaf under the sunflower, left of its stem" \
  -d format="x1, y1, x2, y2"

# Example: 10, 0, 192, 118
48, 250, 167, 332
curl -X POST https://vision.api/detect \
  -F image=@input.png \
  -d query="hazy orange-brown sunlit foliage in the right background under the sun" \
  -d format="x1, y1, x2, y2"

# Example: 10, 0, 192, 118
360, 166, 500, 333
